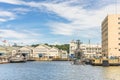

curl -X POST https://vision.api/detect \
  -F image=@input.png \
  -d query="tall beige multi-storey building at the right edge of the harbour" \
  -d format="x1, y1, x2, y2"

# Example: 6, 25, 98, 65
101, 14, 120, 58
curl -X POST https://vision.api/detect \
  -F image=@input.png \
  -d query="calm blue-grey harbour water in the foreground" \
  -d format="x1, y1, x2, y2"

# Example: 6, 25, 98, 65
0, 61, 120, 80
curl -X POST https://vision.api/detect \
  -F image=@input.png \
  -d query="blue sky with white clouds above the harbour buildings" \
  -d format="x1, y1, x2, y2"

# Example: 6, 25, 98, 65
0, 0, 120, 45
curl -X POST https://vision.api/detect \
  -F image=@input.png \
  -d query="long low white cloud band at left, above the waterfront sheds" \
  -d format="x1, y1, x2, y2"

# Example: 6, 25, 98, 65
0, 29, 42, 39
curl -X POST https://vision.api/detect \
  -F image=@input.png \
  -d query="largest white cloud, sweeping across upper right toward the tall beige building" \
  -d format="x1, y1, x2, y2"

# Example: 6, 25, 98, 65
35, 2, 120, 37
